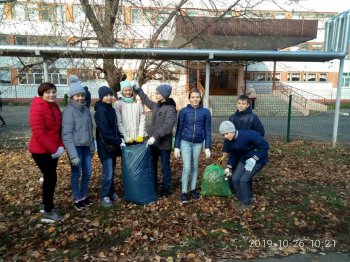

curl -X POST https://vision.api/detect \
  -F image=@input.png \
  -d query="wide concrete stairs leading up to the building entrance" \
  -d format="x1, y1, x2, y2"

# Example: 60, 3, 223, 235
209, 94, 303, 117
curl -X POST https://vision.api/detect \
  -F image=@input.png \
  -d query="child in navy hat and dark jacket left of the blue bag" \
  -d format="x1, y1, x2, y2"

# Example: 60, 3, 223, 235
95, 86, 125, 207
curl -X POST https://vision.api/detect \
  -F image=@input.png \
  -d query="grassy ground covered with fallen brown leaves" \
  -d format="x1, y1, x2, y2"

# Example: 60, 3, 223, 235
0, 141, 350, 261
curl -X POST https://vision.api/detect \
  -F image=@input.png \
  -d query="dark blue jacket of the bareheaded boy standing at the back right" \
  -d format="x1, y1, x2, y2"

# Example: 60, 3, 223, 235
228, 107, 265, 136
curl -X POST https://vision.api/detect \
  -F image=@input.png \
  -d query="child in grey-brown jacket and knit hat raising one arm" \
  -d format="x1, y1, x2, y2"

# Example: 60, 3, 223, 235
133, 84, 176, 197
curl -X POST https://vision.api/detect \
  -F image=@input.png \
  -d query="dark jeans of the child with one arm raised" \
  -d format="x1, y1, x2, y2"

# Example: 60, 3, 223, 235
151, 147, 171, 193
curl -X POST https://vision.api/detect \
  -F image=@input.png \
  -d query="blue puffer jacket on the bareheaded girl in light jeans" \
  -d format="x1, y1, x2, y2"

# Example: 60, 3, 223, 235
175, 104, 211, 148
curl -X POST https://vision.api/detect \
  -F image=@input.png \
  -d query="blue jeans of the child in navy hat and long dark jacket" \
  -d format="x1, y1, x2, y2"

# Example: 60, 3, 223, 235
101, 157, 117, 198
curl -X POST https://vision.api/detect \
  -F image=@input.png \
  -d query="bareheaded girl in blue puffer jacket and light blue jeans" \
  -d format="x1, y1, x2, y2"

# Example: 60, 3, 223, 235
174, 89, 211, 203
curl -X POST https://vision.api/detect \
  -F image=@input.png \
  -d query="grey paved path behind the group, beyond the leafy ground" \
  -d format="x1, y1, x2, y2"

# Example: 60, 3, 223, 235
0, 106, 350, 145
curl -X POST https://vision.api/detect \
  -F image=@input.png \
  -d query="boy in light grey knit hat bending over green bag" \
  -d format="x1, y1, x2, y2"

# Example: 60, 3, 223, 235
219, 121, 269, 210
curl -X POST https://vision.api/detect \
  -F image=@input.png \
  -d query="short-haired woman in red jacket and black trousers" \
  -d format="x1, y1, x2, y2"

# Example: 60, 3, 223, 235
29, 83, 64, 223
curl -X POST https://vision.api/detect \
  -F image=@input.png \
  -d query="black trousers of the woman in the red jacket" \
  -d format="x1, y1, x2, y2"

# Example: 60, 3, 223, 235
32, 154, 58, 212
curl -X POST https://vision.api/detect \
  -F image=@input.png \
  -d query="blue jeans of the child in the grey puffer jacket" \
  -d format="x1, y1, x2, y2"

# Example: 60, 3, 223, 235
71, 146, 91, 201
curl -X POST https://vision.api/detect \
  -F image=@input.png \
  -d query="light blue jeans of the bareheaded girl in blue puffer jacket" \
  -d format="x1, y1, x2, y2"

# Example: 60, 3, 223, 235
180, 140, 203, 193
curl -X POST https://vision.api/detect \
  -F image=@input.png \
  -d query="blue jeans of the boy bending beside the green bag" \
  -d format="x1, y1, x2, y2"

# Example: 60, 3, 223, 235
232, 162, 264, 205
